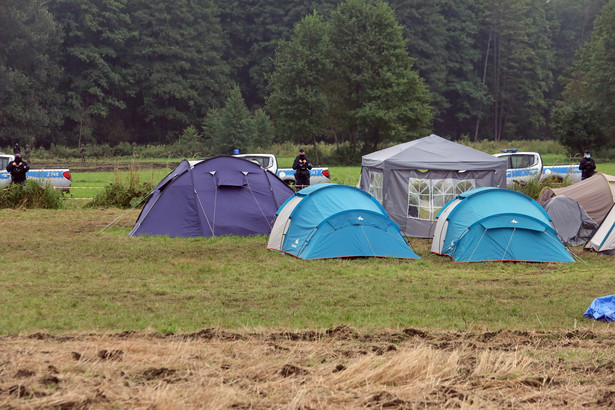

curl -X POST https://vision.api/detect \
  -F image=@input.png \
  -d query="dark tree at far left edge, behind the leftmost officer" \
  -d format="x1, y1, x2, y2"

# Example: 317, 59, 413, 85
0, 0, 62, 146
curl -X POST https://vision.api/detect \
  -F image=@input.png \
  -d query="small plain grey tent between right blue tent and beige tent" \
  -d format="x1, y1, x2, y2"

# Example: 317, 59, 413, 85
544, 195, 598, 246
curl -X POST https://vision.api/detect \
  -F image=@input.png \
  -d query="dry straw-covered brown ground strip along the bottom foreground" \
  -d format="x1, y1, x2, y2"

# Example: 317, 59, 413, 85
0, 326, 615, 409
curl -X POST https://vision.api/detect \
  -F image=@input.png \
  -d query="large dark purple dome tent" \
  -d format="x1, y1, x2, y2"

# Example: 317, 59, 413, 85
129, 157, 293, 237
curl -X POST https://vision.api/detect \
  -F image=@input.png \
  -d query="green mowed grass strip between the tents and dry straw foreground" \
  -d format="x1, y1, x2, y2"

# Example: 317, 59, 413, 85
0, 209, 615, 334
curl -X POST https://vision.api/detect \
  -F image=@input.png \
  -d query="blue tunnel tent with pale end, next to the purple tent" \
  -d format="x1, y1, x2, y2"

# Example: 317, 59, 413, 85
267, 184, 420, 259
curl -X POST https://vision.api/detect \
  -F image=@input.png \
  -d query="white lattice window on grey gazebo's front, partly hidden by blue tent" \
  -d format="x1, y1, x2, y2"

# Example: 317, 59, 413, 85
408, 178, 476, 221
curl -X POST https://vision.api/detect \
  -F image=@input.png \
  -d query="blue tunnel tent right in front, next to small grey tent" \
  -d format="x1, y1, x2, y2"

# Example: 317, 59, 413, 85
431, 188, 574, 262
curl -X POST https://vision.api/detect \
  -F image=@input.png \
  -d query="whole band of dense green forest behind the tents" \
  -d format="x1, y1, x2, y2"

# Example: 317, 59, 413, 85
0, 0, 615, 153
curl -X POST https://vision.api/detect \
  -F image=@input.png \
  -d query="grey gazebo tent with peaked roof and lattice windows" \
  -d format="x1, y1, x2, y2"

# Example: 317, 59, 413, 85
359, 134, 506, 238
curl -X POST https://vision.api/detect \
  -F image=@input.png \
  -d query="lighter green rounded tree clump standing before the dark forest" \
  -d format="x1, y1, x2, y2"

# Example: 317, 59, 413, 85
268, 0, 432, 151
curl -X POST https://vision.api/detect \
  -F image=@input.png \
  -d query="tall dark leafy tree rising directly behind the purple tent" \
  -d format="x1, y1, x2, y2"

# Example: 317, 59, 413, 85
126, 0, 230, 140
